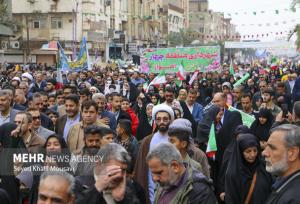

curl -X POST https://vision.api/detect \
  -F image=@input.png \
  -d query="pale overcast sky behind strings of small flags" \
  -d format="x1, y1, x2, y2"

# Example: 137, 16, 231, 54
209, 0, 300, 41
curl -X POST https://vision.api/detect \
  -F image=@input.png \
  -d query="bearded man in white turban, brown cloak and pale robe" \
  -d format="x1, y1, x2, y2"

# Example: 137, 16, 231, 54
134, 104, 174, 204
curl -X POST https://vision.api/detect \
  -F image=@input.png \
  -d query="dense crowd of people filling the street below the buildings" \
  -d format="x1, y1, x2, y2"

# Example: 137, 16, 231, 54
0, 62, 300, 204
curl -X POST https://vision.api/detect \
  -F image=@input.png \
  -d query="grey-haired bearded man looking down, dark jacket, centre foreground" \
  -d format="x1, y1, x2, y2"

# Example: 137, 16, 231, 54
147, 143, 216, 204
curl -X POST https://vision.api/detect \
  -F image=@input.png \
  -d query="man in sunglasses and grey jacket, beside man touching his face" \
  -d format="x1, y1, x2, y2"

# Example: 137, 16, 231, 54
27, 108, 55, 140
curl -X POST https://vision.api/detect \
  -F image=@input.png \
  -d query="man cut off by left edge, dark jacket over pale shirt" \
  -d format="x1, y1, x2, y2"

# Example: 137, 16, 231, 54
0, 90, 19, 125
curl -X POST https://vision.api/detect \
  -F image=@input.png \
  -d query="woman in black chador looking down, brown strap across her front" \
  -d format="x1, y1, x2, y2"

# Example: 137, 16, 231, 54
225, 134, 273, 204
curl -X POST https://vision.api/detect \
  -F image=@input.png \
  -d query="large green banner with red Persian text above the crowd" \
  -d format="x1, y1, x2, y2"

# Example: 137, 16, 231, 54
140, 46, 220, 73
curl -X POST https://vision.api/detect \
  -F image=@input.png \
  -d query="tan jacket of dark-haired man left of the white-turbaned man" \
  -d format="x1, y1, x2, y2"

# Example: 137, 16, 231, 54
67, 120, 109, 153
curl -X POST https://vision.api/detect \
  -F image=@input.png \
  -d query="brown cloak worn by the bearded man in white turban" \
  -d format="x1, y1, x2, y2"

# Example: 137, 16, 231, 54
133, 135, 153, 204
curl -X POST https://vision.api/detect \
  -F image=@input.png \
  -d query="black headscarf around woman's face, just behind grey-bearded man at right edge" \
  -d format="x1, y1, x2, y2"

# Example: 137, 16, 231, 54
250, 108, 274, 141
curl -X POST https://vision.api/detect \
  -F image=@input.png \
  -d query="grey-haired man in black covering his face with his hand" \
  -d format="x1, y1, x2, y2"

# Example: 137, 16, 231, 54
75, 143, 146, 204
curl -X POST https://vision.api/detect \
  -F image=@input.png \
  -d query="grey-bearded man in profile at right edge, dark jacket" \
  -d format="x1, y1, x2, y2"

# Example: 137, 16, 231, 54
263, 124, 300, 204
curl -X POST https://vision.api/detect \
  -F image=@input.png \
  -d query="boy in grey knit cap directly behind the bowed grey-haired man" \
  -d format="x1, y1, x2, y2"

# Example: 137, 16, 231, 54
168, 118, 209, 177
